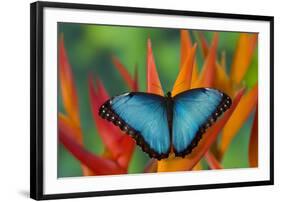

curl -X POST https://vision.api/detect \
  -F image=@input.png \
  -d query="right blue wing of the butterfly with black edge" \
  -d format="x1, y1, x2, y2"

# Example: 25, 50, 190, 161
172, 88, 231, 157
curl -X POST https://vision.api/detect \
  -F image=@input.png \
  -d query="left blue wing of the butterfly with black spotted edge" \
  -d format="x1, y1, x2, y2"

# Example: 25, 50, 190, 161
99, 92, 171, 159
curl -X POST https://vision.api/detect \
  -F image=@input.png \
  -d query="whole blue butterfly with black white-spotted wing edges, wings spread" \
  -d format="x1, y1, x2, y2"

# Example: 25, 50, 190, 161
99, 88, 232, 160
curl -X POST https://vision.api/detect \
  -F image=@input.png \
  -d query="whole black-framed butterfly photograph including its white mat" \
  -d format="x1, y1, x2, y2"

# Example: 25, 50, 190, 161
30, 2, 274, 200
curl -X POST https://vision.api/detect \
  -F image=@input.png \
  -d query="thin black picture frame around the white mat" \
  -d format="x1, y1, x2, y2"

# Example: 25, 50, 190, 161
30, 2, 274, 200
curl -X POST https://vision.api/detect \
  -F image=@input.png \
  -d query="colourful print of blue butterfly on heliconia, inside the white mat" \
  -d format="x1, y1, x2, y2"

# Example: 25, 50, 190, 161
58, 23, 258, 177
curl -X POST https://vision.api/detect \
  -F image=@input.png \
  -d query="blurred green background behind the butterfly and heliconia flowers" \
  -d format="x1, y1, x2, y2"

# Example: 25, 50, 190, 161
58, 23, 258, 177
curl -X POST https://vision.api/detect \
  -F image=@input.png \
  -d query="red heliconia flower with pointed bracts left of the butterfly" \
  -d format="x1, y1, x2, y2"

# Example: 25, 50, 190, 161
58, 36, 138, 175
